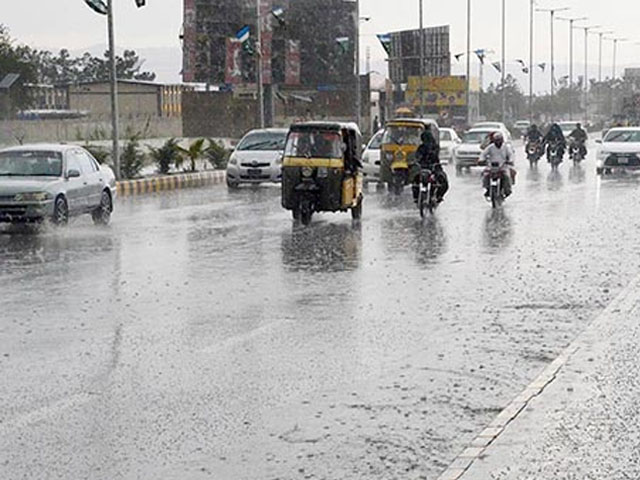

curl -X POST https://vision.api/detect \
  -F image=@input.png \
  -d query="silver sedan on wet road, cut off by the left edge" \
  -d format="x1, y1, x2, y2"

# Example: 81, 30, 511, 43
0, 144, 116, 225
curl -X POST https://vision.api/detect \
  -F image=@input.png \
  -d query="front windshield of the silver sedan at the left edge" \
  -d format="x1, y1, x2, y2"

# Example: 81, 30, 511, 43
0, 150, 62, 177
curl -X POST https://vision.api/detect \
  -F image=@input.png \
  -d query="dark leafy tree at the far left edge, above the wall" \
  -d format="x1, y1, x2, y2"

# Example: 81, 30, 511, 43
0, 24, 37, 118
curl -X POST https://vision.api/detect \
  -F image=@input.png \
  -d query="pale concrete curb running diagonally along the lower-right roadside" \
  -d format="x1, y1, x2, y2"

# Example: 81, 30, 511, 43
438, 276, 640, 480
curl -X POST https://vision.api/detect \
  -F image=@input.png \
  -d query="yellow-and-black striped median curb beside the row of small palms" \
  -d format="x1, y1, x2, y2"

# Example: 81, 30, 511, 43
117, 170, 226, 197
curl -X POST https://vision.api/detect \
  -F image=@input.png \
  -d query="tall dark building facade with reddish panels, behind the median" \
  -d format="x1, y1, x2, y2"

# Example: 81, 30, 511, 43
182, 0, 357, 87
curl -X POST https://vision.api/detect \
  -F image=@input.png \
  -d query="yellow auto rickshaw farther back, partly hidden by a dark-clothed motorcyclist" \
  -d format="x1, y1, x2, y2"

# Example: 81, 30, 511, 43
380, 118, 440, 195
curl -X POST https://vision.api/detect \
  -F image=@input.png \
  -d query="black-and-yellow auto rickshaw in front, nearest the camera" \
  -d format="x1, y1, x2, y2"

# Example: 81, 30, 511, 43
282, 122, 362, 225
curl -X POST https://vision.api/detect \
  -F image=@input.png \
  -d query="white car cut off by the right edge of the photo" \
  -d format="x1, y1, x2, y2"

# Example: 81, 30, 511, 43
596, 127, 640, 175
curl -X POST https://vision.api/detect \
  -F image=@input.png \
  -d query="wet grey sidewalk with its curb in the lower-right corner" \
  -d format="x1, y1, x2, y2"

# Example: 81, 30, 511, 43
440, 277, 640, 480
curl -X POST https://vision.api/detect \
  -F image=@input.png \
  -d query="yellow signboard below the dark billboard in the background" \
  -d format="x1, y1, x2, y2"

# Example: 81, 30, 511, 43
406, 77, 473, 107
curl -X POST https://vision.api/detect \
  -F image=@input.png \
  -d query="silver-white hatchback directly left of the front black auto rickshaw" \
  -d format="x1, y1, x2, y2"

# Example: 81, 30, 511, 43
227, 128, 288, 188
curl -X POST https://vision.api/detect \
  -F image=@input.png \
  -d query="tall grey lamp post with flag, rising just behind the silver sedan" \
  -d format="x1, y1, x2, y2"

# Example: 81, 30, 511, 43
85, 0, 146, 179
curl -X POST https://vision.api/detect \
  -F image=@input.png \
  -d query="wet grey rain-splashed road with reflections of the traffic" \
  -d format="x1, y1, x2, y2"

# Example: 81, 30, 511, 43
0, 141, 640, 480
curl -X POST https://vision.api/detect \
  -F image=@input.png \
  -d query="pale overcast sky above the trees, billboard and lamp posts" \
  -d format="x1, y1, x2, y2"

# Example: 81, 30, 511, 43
0, 0, 640, 90
